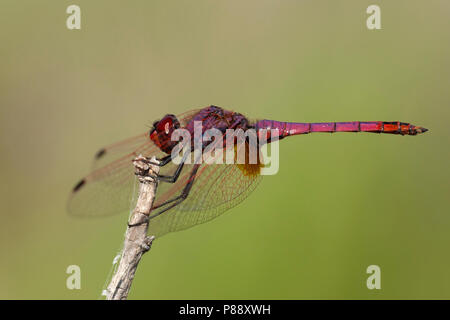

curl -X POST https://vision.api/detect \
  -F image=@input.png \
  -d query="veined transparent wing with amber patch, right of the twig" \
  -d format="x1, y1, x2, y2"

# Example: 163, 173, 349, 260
149, 164, 262, 237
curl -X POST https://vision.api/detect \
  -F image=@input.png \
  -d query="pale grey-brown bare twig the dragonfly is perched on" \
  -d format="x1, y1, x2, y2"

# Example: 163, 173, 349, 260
106, 156, 159, 300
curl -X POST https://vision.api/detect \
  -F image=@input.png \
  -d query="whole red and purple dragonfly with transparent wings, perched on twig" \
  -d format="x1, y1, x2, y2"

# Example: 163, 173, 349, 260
68, 105, 428, 238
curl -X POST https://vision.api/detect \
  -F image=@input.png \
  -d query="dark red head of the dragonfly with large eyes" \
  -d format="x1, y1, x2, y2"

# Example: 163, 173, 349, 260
150, 114, 180, 154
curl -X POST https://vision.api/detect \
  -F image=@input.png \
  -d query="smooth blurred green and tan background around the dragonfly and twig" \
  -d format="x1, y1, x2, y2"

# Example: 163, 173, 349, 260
0, 0, 450, 299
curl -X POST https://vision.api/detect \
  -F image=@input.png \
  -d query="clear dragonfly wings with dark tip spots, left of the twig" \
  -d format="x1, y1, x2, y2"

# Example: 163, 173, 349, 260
67, 110, 198, 216
